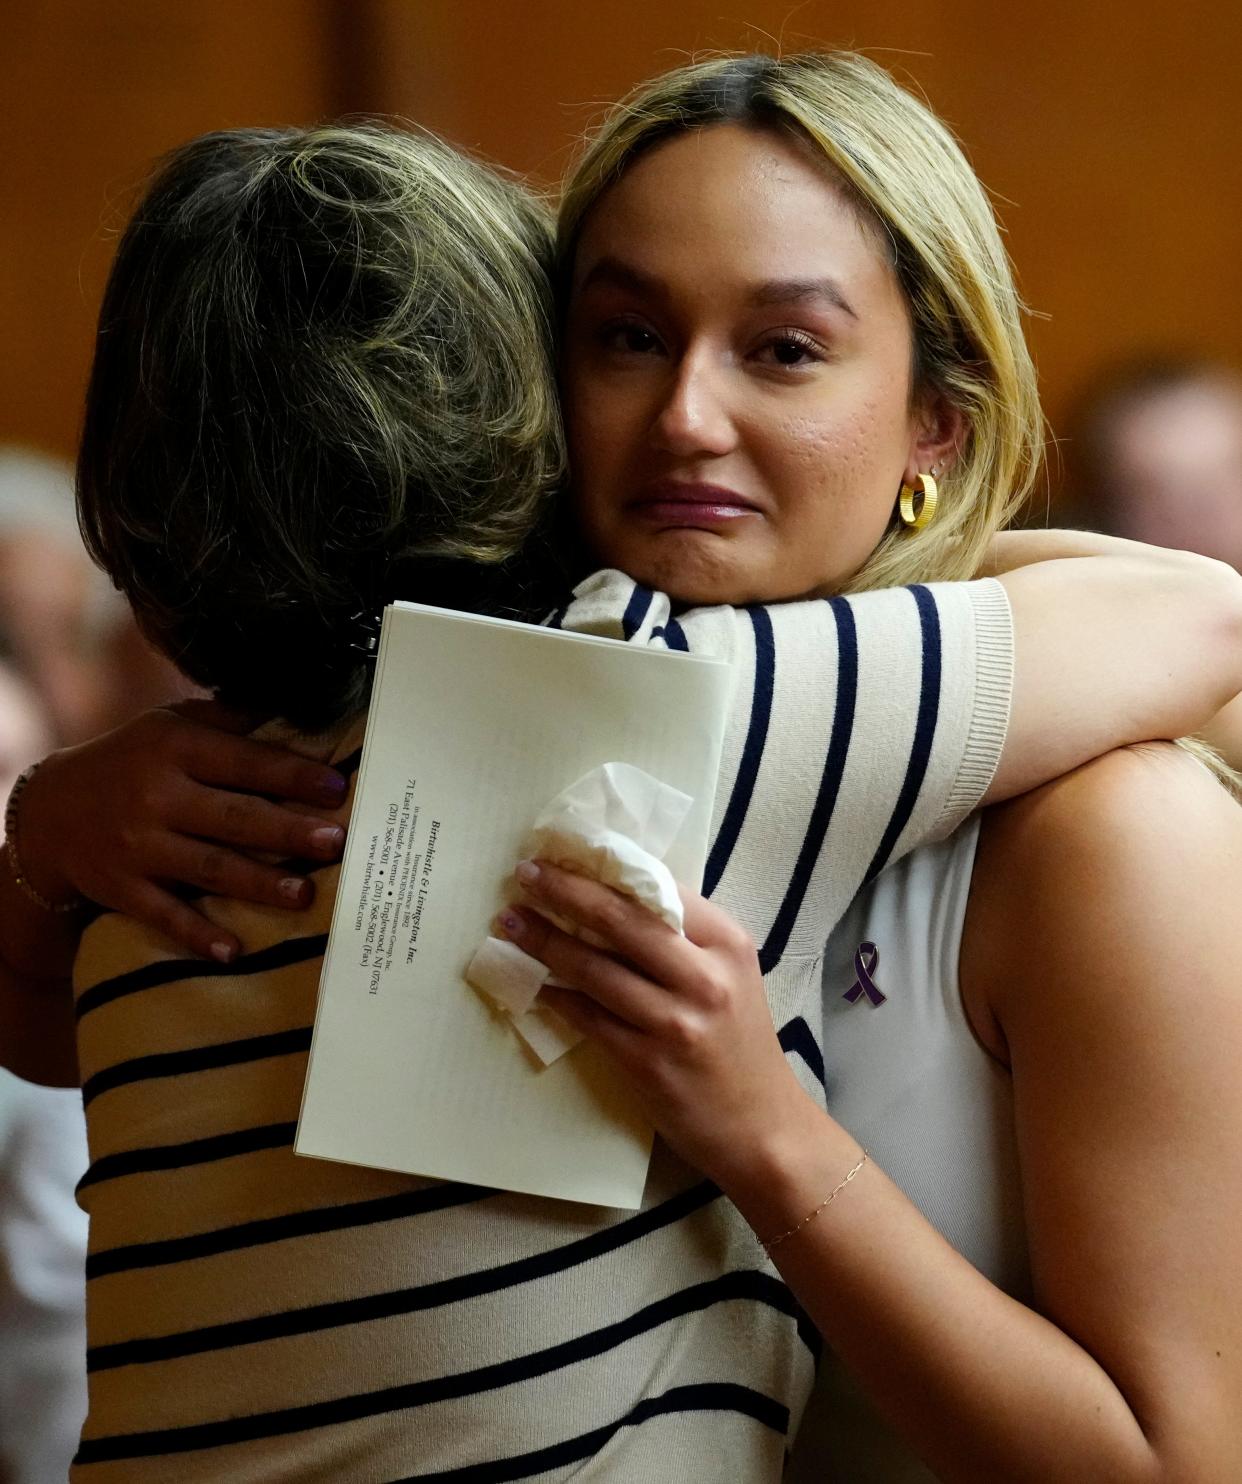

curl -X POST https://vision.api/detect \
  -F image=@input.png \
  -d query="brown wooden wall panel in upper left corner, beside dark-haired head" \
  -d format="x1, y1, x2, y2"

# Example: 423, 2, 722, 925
0, 0, 332, 453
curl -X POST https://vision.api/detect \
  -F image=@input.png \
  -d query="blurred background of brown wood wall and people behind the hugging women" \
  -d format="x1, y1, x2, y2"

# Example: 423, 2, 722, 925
0, 0, 1242, 1484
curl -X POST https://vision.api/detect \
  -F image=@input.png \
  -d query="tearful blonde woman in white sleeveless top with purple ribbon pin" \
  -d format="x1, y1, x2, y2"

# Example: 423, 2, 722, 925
495, 56, 1242, 1484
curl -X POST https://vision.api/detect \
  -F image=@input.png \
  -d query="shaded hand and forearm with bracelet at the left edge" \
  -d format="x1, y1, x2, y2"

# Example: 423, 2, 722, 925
0, 703, 347, 1085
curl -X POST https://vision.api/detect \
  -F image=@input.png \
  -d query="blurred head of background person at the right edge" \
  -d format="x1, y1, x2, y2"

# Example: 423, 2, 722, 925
1067, 356, 1242, 767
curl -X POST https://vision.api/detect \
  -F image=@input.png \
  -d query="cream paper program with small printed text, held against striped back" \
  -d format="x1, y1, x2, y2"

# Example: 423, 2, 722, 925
294, 604, 732, 1208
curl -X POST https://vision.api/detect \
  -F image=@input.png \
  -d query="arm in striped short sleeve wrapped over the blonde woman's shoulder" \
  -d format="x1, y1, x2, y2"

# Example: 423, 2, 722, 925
664, 531, 1242, 937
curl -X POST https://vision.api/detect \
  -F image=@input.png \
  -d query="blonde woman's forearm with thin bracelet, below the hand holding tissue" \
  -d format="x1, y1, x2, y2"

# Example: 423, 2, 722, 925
721, 1101, 1166, 1484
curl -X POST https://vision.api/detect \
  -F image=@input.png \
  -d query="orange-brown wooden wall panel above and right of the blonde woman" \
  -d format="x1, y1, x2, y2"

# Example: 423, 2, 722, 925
374, 0, 1242, 451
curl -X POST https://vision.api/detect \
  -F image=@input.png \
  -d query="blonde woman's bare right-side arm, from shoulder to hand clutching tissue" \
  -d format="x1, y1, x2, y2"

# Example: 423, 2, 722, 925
516, 754, 1242, 1484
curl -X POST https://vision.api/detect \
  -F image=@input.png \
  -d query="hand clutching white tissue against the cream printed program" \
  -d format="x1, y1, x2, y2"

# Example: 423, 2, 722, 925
500, 861, 809, 1187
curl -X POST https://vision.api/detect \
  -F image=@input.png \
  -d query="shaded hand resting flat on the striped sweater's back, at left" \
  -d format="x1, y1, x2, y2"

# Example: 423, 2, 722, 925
19, 702, 347, 962
